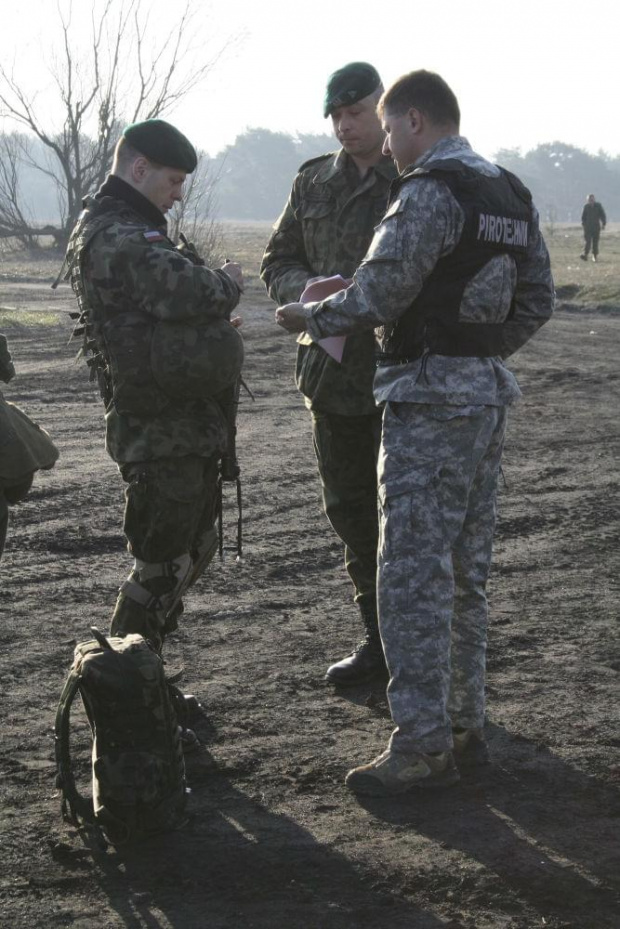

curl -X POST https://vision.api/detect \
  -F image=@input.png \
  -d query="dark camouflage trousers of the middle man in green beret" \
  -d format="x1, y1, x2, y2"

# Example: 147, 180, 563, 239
312, 410, 381, 615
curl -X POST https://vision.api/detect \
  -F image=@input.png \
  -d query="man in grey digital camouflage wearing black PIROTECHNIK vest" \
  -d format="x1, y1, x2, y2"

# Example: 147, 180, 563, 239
276, 71, 553, 796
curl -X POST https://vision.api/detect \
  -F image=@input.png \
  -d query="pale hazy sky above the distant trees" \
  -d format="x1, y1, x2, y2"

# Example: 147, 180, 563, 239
0, 0, 620, 156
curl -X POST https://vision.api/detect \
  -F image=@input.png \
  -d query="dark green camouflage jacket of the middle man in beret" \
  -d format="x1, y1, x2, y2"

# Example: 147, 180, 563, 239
261, 150, 396, 416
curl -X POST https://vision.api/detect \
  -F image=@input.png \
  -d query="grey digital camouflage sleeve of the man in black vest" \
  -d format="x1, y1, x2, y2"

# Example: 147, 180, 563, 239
307, 178, 456, 339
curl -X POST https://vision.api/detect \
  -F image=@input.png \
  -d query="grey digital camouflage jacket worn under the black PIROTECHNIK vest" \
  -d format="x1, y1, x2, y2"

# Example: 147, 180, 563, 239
306, 136, 554, 406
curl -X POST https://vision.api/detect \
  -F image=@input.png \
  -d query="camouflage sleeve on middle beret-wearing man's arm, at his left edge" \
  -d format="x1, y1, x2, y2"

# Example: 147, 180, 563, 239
260, 176, 315, 304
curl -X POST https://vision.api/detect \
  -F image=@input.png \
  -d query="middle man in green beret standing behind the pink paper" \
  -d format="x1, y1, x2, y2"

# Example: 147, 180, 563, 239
261, 62, 396, 685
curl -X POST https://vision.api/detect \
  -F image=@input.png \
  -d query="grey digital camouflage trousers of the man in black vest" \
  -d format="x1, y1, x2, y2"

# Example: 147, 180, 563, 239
378, 403, 506, 752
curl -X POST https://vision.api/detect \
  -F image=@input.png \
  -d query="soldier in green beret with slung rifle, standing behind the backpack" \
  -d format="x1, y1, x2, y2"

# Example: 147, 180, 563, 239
66, 120, 242, 649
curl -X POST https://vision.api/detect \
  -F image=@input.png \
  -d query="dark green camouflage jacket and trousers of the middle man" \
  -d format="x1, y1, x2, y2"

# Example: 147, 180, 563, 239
261, 150, 396, 615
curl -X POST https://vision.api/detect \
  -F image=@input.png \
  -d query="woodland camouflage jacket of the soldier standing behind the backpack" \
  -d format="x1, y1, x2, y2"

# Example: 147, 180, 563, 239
66, 177, 239, 463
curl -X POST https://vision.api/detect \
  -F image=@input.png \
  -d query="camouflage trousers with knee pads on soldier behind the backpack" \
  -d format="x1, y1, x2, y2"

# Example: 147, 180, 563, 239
111, 455, 218, 648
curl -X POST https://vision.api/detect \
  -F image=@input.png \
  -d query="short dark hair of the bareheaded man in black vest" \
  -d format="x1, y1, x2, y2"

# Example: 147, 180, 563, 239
379, 70, 461, 128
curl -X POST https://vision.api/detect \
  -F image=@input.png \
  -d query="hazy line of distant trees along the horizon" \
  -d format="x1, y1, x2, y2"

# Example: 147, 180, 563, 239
0, 128, 620, 244
